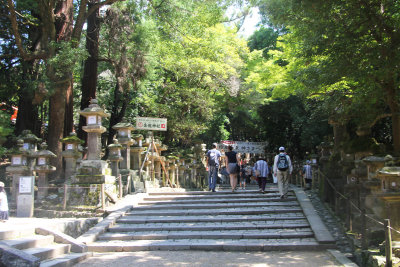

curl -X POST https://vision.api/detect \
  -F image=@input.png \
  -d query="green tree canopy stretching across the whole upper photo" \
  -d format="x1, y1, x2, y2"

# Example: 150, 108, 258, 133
0, 0, 400, 161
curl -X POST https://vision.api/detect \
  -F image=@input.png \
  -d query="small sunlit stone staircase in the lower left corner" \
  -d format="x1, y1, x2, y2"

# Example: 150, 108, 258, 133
0, 225, 92, 267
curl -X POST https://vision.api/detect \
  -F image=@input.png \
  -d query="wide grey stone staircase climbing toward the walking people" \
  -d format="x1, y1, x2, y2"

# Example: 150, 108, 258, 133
88, 186, 335, 252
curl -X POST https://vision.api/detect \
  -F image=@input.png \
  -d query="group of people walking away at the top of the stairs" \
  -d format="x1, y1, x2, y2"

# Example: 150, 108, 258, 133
206, 143, 312, 198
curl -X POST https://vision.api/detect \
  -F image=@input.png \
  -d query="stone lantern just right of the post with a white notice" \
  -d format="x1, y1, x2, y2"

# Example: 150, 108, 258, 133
33, 142, 57, 199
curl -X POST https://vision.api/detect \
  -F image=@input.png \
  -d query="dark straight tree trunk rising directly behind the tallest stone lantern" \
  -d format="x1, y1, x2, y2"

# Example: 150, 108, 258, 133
78, 0, 100, 142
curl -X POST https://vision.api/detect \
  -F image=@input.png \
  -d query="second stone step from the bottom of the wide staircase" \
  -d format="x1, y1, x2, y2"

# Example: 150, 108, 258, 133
98, 228, 314, 241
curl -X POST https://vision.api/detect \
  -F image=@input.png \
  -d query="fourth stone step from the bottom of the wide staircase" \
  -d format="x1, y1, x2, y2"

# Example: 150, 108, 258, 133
117, 213, 307, 224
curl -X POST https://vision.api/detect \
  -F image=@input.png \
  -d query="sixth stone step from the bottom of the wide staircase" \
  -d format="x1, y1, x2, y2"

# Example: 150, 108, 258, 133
133, 203, 299, 211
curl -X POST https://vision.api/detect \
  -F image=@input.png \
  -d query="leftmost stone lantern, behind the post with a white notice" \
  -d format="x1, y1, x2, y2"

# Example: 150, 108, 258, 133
6, 139, 32, 201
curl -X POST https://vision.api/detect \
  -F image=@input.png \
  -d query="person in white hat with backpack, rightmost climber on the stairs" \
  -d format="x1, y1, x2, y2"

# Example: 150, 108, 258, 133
274, 146, 293, 198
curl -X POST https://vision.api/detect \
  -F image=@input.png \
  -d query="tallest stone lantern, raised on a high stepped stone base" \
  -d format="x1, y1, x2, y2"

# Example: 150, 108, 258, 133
79, 99, 110, 160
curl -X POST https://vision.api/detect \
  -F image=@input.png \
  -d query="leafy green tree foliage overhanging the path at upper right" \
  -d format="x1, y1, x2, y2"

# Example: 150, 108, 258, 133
258, 0, 400, 153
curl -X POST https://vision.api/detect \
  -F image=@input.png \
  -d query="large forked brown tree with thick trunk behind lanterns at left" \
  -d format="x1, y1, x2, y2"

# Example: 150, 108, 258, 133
7, 0, 117, 176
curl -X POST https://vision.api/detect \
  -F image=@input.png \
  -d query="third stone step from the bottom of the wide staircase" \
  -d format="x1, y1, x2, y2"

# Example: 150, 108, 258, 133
108, 221, 310, 233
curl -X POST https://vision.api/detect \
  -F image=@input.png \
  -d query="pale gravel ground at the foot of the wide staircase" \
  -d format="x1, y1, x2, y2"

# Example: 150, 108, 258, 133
75, 251, 343, 267
